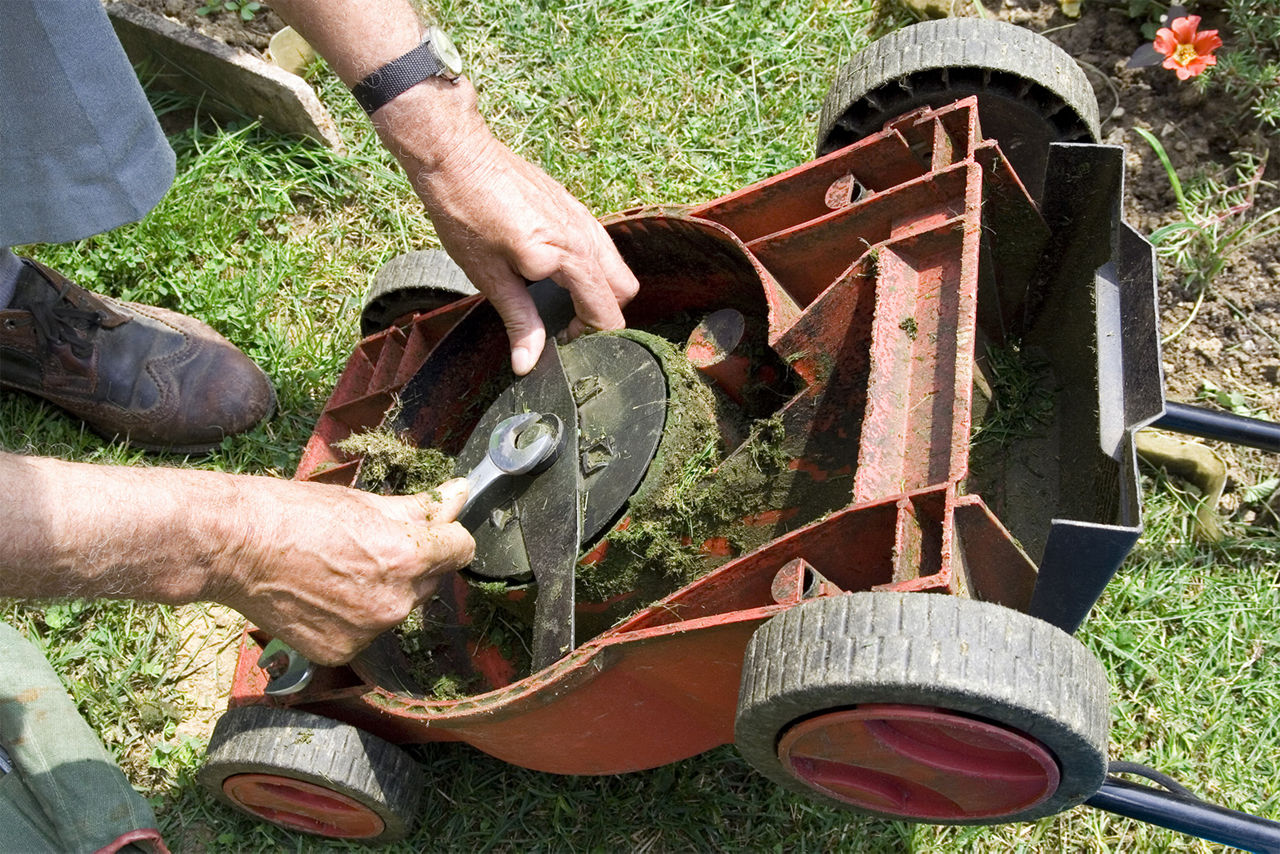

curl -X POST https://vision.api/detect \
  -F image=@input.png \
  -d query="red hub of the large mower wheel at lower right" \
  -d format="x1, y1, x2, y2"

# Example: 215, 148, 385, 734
778, 704, 1060, 821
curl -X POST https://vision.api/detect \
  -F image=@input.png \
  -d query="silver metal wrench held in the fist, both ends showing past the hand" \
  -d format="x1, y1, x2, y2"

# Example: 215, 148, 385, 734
257, 412, 562, 697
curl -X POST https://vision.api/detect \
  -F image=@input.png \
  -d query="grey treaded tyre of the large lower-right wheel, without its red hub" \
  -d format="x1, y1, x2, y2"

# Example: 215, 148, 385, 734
735, 593, 1108, 823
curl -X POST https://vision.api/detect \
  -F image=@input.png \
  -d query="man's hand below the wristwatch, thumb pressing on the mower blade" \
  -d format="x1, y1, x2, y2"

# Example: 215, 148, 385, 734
374, 81, 640, 375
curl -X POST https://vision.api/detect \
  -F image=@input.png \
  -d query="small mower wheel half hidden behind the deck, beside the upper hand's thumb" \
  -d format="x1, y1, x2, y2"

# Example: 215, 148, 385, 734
360, 250, 479, 335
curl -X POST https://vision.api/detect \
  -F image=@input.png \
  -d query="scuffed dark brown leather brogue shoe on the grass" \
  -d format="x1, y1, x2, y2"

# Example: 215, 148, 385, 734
0, 259, 275, 453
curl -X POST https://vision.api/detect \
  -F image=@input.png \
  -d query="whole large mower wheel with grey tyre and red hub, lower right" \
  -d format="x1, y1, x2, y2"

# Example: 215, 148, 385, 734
735, 593, 1108, 825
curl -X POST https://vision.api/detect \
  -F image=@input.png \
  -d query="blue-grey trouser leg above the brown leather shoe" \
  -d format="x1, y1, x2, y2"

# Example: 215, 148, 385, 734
0, 0, 174, 246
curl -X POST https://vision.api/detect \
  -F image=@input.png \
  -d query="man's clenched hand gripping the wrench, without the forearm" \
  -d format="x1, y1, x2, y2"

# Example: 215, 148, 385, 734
214, 480, 475, 665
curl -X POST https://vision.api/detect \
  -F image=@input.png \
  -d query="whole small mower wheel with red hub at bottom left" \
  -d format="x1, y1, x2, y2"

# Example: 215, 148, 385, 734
198, 705, 425, 842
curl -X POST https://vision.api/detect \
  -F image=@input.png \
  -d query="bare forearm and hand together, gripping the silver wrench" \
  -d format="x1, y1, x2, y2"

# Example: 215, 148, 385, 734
0, 452, 475, 665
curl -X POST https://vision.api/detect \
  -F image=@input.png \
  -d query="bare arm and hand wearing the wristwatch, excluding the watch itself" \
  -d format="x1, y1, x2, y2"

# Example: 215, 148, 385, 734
271, 0, 639, 374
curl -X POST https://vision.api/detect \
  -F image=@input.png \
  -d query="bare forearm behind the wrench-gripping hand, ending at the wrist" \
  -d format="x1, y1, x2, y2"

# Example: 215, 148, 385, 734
0, 453, 241, 603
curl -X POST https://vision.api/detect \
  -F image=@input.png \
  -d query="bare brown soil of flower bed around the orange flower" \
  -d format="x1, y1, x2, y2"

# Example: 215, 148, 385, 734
989, 0, 1280, 507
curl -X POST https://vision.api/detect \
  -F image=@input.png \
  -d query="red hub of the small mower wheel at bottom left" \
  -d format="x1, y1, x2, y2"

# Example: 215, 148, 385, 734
223, 773, 387, 839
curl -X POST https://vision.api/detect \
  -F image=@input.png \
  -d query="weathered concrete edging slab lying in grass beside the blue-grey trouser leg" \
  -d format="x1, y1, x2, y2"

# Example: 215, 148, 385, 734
106, 3, 342, 150
